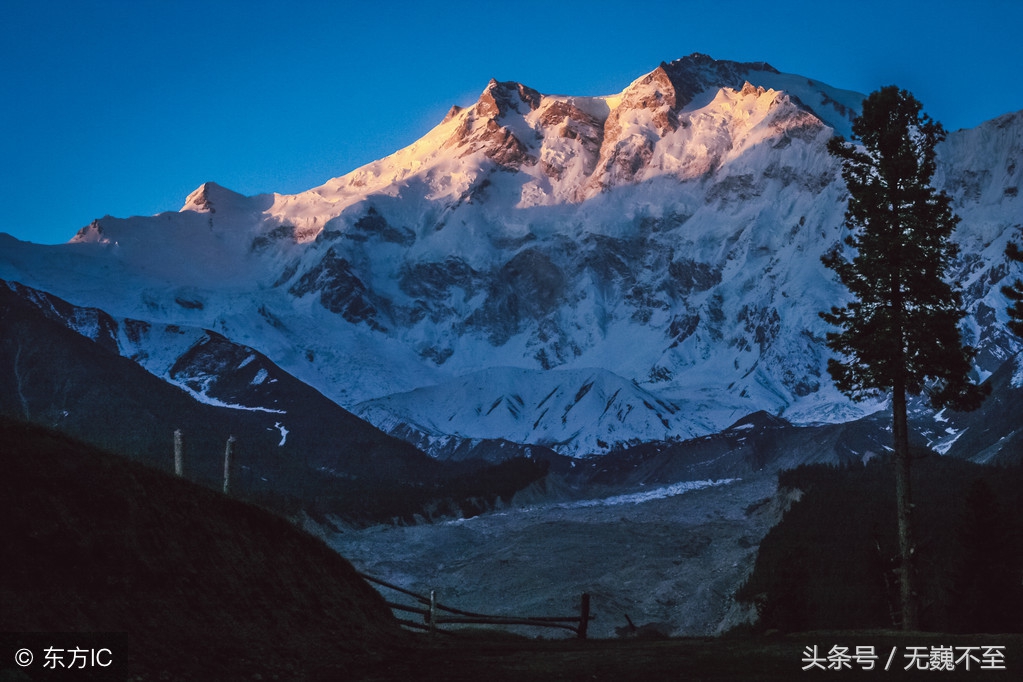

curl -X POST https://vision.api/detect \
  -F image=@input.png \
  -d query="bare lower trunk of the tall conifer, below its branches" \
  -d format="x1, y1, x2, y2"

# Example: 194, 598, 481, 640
892, 378, 920, 630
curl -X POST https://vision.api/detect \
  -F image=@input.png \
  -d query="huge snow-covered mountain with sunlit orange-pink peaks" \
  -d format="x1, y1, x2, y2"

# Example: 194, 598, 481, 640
0, 54, 1023, 455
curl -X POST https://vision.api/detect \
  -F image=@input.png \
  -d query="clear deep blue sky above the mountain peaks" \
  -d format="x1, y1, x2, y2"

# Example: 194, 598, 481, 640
0, 0, 1023, 243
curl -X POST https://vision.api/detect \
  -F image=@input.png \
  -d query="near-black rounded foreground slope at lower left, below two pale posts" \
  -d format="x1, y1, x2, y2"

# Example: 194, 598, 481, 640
0, 418, 404, 680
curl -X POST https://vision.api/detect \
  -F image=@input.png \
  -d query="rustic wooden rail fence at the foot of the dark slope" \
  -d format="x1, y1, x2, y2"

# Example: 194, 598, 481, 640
359, 573, 595, 639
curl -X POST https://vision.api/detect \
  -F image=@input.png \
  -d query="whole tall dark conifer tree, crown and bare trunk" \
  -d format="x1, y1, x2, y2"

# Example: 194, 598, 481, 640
820, 86, 984, 630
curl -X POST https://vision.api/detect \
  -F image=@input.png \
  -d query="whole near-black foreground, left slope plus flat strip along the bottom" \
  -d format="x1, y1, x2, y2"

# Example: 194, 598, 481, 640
0, 419, 1023, 682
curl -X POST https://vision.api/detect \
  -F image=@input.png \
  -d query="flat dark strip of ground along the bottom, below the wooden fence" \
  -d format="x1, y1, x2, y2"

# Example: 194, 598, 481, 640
353, 631, 1023, 682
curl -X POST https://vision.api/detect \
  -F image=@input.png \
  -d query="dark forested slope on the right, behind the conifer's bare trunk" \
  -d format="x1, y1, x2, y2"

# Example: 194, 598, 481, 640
738, 451, 1023, 633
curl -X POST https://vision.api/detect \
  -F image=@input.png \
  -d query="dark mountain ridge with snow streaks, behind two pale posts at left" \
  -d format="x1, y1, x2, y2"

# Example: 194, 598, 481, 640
0, 281, 543, 521
